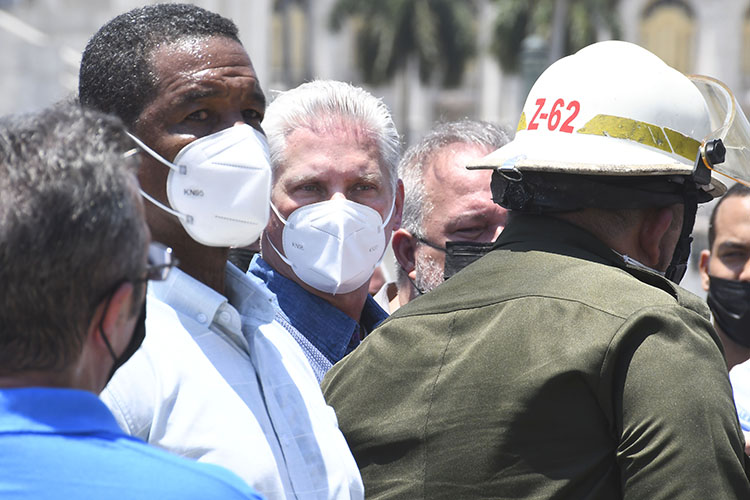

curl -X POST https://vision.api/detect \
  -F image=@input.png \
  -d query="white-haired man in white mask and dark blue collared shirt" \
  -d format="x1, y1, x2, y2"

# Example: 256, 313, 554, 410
249, 80, 404, 381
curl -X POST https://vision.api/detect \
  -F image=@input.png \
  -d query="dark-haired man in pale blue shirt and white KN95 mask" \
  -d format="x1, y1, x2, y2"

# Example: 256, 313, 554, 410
79, 4, 363, 499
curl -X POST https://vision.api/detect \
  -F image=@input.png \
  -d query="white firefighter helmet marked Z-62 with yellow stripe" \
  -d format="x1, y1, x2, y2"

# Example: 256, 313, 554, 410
469, 41, 750, 197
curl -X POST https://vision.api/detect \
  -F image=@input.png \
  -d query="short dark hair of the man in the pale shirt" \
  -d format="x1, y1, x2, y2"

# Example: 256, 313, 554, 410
78, 3, 240, 127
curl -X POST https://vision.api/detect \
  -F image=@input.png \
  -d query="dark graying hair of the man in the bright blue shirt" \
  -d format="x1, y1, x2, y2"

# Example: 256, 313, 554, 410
0, 103, 148, 373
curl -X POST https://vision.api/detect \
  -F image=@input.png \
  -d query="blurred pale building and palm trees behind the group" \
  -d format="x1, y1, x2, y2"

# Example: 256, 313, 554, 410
0, 0, 750, 296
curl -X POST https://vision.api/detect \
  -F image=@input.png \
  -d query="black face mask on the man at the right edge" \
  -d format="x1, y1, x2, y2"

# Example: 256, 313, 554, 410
707, 276, 750, 347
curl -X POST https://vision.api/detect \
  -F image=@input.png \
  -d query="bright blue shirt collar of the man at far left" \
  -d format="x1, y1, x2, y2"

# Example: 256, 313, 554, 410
0, 387, 123, 435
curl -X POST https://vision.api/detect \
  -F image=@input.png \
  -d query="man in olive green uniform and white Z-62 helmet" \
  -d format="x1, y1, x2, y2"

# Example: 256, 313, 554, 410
323, 42, 750, 500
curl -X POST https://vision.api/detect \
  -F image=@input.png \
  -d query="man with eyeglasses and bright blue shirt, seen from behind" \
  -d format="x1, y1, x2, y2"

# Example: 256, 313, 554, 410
0, 104, 259, 500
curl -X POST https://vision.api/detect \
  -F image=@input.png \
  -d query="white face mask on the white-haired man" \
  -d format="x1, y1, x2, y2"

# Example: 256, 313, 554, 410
269, 199, 396, 295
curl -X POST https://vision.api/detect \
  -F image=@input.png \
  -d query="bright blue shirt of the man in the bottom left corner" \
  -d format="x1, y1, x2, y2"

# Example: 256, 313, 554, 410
0, 387, 261, 500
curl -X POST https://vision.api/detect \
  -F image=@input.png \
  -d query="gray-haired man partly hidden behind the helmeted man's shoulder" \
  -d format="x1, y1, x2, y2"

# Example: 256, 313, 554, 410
391, 120, 510, 312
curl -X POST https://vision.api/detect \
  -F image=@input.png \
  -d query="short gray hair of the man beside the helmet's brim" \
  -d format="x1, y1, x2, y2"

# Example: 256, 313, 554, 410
398, 120, 510, 238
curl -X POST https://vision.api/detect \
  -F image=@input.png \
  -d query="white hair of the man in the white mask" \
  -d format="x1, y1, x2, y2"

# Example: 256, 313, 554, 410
263, 80, 401, 190
